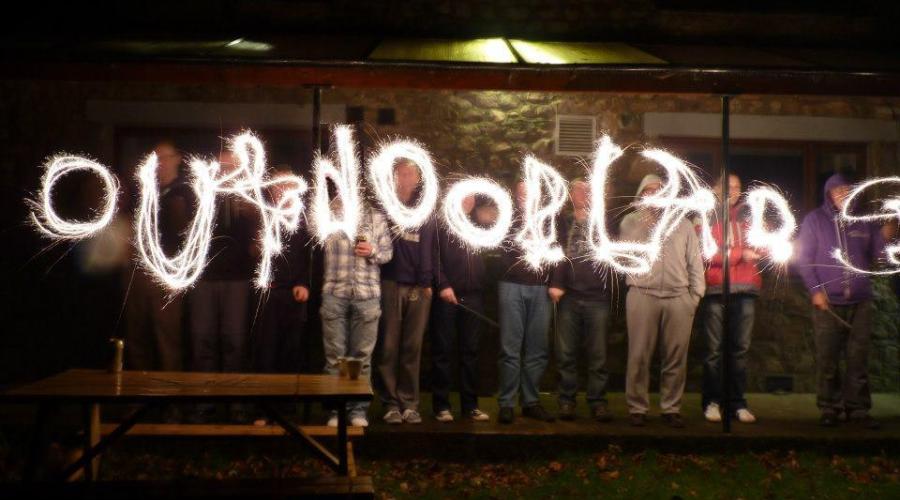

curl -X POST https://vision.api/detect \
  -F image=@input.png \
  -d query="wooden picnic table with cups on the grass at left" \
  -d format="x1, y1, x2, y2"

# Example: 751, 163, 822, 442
0, 369, 372, 481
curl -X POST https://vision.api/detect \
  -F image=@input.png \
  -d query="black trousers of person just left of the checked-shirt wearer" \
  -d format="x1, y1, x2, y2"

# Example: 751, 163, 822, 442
253, 288, 311, 373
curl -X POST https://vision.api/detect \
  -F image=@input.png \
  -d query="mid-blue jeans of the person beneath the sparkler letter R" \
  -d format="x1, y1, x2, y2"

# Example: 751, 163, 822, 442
497, 281, 550, 408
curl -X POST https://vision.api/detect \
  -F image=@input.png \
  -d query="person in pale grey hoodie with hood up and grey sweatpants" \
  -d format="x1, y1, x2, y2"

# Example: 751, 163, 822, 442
620, 174, 706, 428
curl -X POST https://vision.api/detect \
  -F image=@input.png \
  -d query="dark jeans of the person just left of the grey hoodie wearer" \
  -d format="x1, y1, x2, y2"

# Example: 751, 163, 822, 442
556, 295, 609, 407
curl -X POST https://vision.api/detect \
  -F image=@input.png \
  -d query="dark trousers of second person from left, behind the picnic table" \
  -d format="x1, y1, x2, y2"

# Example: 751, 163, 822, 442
188, 280, 250, 372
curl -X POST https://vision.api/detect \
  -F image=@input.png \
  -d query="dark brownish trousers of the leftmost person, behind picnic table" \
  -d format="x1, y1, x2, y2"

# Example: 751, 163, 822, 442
125, 269, 184, 371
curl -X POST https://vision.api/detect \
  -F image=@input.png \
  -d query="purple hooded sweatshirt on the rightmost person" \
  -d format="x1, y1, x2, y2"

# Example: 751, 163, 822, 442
796, 174, 884, 305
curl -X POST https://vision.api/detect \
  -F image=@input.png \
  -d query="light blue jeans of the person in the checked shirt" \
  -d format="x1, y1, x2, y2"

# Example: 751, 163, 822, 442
320, 294, 381, 418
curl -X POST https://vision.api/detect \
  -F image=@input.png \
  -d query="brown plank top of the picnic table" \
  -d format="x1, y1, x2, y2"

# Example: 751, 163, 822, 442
0, 369, 372, 402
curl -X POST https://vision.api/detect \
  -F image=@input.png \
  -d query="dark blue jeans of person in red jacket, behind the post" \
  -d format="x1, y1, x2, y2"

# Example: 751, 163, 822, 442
701, 293, 756, 410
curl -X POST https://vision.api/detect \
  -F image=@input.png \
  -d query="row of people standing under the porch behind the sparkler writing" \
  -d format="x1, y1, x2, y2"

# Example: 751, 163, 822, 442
126, 143, 883, 428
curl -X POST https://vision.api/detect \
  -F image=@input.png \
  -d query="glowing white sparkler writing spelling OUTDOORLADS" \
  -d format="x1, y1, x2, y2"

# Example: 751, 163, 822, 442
28, 125, 900, 291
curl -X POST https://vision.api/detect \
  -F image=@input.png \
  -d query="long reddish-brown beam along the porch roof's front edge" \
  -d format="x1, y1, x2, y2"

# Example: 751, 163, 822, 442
0, 61, 900, 96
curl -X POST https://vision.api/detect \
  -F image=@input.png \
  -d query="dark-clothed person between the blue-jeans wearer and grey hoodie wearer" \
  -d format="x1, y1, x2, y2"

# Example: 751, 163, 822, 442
554, 179, 612, 422
